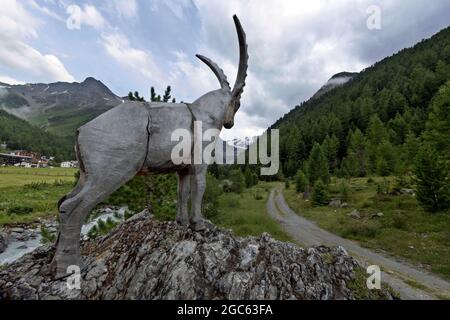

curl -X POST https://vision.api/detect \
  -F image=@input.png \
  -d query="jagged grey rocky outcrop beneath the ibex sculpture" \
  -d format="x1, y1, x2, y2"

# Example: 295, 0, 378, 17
0, 212, 390, 300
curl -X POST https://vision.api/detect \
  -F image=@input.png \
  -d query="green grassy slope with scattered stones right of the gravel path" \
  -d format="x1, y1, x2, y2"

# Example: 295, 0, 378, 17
284, 178, 450, 279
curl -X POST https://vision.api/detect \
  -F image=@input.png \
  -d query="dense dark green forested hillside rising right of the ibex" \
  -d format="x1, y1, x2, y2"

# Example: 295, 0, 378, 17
272, 28, 450, 179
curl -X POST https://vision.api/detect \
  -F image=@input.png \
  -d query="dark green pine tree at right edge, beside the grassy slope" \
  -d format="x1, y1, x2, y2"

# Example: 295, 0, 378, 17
413, 144, 450, 212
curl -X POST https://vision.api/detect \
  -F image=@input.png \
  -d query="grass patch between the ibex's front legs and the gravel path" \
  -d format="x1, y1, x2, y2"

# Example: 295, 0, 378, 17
212, 182, 292, 241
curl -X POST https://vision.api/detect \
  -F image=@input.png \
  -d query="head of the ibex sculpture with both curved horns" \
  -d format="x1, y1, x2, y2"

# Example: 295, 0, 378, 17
197, 15, 248, 129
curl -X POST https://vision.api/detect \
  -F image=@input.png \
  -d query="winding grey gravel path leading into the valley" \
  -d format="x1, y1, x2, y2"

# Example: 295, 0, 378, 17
267, 189, 450, 300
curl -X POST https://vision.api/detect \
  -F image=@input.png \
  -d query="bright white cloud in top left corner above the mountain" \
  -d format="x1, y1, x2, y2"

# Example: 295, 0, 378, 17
0, 0, 74, 81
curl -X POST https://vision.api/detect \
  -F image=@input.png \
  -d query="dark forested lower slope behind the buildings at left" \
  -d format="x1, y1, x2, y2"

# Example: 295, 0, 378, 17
0, 110, 75, 161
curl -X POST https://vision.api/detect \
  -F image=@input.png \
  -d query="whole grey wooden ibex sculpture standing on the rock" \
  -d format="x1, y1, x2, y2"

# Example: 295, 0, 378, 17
52, 16, 248, 276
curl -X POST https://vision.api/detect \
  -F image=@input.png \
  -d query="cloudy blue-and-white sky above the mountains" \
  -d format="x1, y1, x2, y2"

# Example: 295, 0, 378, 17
0, 0, 450, 138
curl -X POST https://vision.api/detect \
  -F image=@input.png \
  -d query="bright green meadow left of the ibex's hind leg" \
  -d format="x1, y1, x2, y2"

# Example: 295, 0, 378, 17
0, 167, 76, 226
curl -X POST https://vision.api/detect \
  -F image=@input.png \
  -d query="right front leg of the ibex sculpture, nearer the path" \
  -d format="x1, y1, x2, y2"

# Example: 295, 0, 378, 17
191, 165, 208, 231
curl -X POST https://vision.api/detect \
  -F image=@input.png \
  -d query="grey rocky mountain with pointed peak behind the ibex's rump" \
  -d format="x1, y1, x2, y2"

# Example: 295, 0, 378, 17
0, 78, 122, 136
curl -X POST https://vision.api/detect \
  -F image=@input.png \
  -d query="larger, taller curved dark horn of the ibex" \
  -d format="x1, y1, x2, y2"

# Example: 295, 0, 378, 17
232, 15, 248, 111
